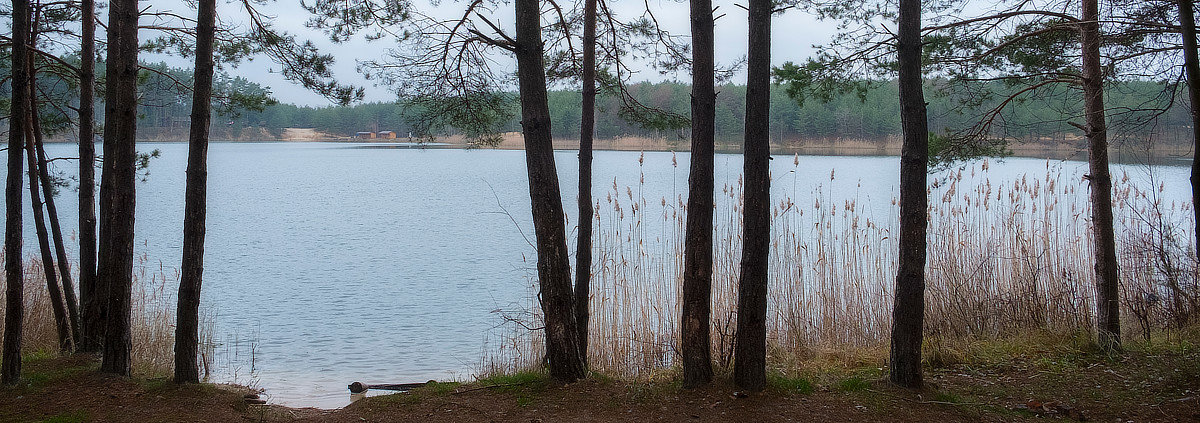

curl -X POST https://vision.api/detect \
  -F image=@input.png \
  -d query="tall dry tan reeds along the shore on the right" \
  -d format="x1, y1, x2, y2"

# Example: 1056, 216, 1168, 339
484, 157, 1200, 379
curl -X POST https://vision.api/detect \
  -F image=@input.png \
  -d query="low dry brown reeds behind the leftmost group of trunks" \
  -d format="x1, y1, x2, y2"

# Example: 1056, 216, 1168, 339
0, 252, 215, 376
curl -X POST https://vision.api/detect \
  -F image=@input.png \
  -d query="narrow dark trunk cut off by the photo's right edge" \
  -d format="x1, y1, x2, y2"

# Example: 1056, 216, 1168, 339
1178, 0, 1200, 264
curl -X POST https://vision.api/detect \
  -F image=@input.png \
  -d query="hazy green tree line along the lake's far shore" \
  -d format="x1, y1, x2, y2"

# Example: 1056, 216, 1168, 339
139, 76, 1192, 144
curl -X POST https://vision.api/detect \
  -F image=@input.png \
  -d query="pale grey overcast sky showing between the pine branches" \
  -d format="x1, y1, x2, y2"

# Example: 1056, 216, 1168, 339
143, 0, 835, 107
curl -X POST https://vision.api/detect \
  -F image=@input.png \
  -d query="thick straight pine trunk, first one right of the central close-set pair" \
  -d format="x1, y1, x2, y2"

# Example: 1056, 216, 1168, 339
889, 0, 929, 388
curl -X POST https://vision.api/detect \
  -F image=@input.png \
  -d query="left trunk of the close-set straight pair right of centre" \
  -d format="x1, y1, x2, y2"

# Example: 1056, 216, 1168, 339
680, 0, 716, 388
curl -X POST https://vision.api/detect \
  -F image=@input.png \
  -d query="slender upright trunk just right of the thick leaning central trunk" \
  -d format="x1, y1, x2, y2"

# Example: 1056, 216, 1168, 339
575, 0, 596, 362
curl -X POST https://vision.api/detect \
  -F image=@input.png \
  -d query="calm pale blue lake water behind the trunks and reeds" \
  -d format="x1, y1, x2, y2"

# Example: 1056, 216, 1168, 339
14, 143, 1190, 407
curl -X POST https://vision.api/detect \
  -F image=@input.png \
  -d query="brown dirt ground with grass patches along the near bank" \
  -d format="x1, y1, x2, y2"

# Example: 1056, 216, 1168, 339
0, 341, 1200, 423
